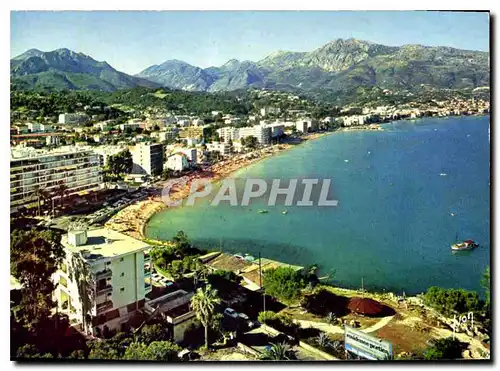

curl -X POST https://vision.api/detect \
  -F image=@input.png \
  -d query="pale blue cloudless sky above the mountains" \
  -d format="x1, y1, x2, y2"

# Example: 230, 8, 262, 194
10, 11, 489, 74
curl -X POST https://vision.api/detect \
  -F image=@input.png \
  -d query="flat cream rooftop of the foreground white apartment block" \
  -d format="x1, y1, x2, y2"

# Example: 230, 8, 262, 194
61, 228, 149, 262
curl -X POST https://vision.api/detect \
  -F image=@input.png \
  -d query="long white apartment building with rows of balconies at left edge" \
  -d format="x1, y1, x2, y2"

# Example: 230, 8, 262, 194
10, 146, 102, 212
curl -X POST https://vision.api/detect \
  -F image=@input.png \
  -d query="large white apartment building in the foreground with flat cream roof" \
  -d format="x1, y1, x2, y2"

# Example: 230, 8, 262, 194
53, 228, 152, 336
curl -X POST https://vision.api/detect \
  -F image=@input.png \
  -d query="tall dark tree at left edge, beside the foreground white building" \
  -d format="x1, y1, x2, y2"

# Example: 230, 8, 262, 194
10, 229, 65, 332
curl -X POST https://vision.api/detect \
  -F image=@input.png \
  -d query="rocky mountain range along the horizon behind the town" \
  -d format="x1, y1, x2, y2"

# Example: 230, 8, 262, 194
11, 39, 490, 99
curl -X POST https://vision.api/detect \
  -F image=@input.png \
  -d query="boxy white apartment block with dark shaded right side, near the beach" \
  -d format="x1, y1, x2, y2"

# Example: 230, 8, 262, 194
130, 143, 163, 175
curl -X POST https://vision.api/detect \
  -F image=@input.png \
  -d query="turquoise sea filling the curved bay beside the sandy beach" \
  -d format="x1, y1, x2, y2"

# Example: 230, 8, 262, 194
146, 116, 490, 294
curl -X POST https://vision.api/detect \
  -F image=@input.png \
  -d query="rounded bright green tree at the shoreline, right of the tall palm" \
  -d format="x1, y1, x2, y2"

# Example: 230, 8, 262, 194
263, 267, 305, 303
